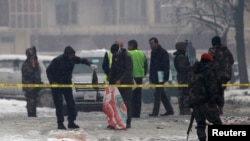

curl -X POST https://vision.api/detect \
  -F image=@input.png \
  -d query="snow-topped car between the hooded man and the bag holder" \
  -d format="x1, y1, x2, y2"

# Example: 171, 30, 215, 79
69, 49, 106, 112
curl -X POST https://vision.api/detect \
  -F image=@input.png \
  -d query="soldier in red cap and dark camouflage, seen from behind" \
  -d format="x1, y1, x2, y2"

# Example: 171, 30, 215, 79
189, 53, 222, 141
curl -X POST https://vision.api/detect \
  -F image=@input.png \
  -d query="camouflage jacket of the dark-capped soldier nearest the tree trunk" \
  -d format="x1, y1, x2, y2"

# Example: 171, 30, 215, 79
208, 45, 234, 83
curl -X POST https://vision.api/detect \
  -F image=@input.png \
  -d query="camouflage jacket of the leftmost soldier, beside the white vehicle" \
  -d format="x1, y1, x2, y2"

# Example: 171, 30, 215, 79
22, 59, 41, 92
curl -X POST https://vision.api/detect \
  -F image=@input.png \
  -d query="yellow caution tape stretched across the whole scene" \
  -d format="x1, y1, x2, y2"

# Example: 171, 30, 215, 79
0, 83, 250, 88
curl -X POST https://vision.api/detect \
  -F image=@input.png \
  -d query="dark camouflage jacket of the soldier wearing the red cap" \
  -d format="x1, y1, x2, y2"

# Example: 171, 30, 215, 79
189, 62, 222, 105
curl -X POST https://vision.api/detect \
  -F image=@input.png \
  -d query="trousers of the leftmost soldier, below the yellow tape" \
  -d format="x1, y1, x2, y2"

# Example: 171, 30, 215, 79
25, 90, 37, 117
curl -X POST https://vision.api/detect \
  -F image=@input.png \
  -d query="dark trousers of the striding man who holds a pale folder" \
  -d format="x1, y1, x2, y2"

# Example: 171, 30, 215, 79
152, 87, 174, 115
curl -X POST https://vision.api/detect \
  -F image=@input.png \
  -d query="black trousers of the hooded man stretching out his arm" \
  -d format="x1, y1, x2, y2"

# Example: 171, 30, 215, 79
52, 88, 77, 123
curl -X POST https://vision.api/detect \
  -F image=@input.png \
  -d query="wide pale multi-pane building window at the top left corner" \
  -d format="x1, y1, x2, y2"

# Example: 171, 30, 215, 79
8, 0, 42, 28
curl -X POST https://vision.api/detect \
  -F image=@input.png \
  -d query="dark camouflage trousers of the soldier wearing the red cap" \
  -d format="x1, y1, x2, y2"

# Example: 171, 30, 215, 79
193, 103, 222, 141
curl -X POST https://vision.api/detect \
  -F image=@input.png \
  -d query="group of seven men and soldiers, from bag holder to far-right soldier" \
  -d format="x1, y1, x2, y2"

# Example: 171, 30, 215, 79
103, 36, 234, 141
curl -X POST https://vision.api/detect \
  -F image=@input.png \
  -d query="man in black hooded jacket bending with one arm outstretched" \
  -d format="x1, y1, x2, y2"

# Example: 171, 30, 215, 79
46, 46, 97, 129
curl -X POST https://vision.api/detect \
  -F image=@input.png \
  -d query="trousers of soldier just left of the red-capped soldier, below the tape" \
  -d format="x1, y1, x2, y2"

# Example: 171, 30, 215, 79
178, 88, 191, 115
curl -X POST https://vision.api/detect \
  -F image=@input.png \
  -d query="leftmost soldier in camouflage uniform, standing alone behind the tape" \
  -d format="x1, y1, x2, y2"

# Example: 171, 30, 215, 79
22, 47, 41, 117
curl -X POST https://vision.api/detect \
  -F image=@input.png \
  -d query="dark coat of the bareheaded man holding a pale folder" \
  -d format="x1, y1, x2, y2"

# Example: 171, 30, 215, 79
149, 45, 169, 84
